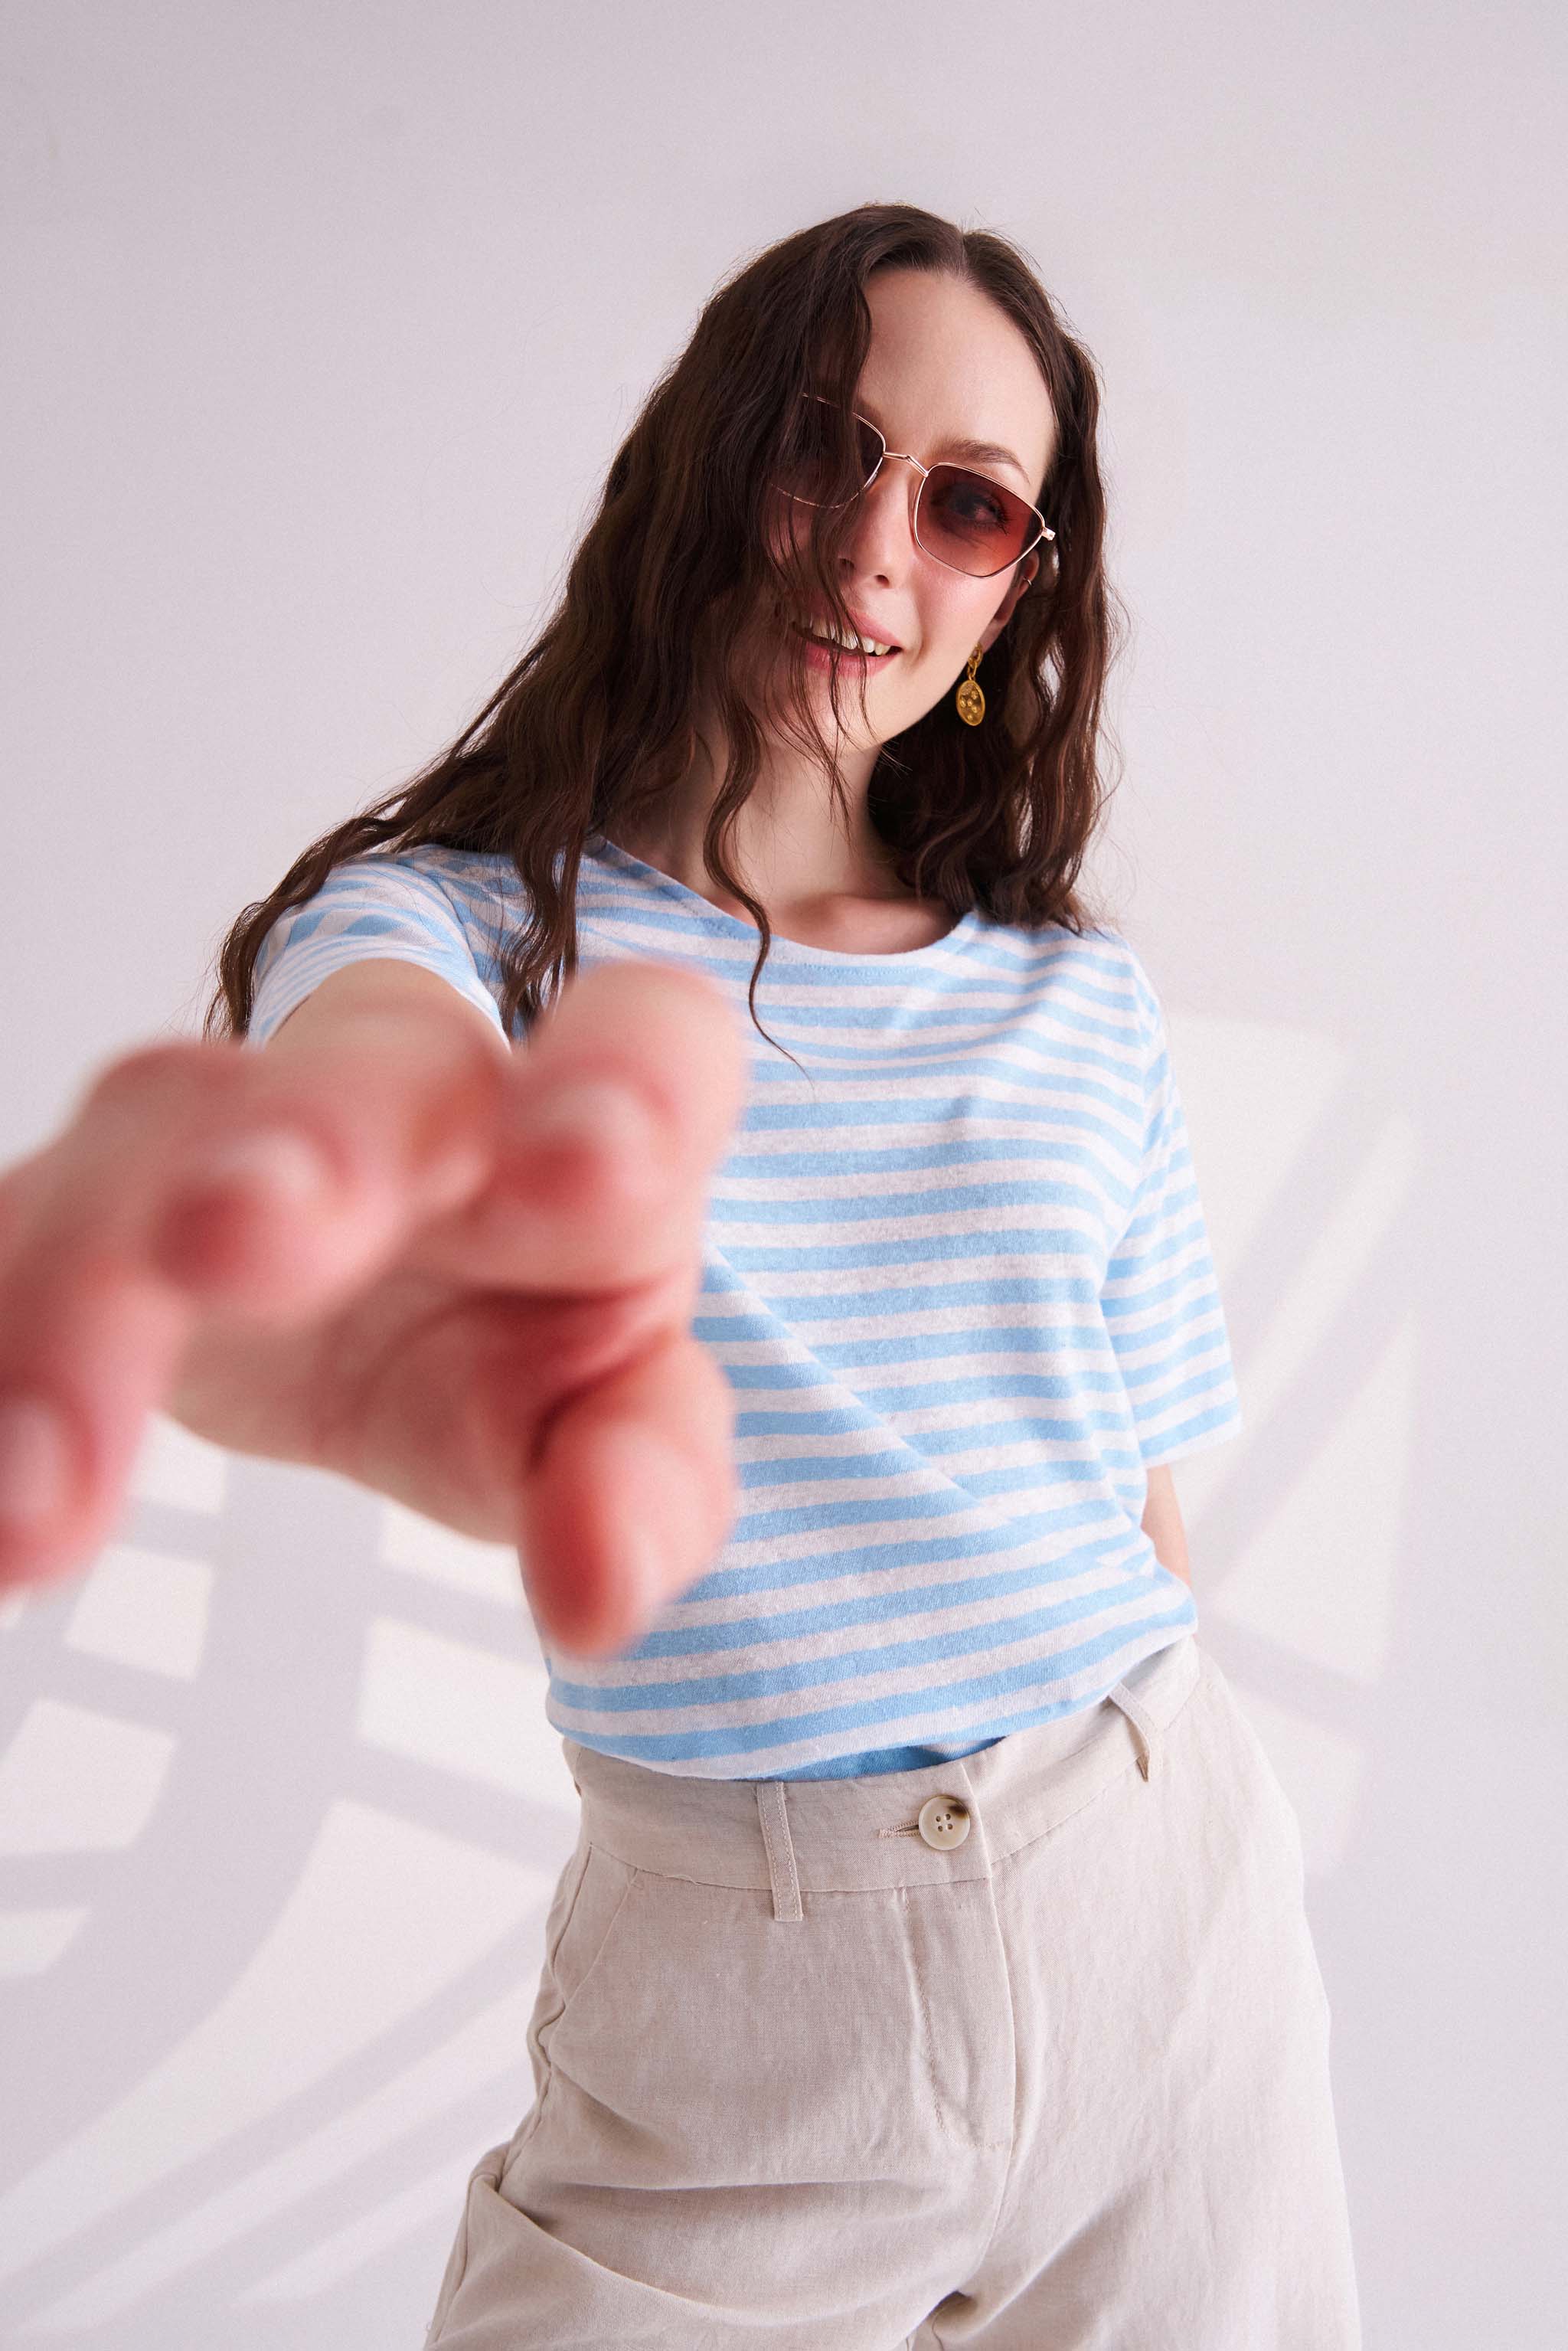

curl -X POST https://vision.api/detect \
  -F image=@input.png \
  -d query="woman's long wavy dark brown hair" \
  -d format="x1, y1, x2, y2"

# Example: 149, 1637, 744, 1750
204, 204, 1126, 1039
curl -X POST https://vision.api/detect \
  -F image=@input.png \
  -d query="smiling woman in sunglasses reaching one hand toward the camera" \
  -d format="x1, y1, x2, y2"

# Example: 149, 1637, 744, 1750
0, 204, 1359, 2351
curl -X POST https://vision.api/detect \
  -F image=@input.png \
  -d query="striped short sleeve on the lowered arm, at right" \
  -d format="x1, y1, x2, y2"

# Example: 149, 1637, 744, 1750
1100, 960, 1241, 1470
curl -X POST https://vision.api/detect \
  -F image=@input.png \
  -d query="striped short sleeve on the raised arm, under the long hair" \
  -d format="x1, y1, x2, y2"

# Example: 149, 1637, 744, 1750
242, 851, 505, 1046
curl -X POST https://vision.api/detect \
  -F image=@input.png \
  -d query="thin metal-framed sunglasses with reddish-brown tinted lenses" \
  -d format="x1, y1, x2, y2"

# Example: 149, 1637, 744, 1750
773, 393, 1056, 580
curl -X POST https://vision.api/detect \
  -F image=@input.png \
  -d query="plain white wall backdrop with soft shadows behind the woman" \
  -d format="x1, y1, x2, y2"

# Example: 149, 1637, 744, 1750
0, 0, 1568, 2351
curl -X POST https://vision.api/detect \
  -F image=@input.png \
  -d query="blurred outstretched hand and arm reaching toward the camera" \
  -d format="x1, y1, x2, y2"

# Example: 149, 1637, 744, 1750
0, 960, 745, 1657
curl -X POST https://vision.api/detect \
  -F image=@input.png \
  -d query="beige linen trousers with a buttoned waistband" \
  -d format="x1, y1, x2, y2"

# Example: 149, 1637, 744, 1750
428, 1632, 1361, 2351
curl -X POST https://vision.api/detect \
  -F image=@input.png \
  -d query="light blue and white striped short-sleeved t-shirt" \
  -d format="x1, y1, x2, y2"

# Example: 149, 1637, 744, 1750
249, 837, 1241, 1780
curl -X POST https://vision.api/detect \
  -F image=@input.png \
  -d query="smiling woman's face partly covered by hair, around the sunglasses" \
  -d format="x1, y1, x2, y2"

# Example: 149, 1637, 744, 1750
756, 270, 1056, 747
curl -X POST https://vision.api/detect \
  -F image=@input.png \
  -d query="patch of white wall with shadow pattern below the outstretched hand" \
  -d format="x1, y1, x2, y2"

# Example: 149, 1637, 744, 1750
0, 1417, 578, 2351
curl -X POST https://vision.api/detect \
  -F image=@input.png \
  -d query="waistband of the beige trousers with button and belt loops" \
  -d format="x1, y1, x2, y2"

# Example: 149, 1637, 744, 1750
562, 1632, 1204, 1921
